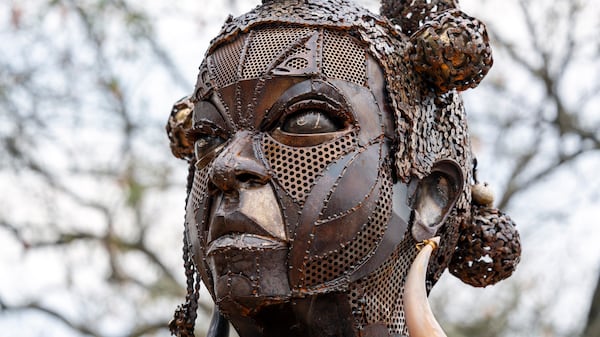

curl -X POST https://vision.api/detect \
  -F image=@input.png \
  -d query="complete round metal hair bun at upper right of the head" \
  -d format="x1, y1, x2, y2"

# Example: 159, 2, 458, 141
409, 9, 493, 93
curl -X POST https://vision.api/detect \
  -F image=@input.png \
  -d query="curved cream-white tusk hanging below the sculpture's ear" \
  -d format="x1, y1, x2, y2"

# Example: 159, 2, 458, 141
404, 237, 447, 337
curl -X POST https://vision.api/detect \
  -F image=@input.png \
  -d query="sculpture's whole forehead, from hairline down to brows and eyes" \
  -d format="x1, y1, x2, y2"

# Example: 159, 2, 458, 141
194, 25, 392, 134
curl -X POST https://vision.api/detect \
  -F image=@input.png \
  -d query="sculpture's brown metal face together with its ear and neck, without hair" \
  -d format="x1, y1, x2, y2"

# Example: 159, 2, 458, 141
172, 26, 474, 336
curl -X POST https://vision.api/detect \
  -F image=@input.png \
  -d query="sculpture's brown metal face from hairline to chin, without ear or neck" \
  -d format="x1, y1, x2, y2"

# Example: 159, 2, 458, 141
187, 29, 404, 310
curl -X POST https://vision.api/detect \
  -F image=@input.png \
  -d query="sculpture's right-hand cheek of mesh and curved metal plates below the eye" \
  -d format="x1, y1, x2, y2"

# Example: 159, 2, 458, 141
262, 135, 392, 288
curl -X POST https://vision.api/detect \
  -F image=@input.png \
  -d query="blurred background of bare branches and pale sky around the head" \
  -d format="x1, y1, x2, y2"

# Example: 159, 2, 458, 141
0, 0, 600, 337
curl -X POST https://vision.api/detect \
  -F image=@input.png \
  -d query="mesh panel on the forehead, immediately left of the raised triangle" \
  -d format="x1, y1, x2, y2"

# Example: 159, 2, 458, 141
242, 27, 313, 79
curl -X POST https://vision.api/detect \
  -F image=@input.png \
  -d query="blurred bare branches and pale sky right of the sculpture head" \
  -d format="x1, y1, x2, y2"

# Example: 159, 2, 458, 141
434, 0, 600, 336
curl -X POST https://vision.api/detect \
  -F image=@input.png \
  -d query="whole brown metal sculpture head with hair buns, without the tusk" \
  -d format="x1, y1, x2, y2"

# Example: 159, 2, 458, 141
167, 0, 519, 337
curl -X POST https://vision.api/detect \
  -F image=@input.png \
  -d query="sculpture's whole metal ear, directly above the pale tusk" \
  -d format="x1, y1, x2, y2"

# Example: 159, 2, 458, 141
411, 160, 464, 242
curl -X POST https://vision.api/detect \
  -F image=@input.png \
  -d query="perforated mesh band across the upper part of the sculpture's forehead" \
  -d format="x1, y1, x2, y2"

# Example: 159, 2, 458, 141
206, 26, 367, 88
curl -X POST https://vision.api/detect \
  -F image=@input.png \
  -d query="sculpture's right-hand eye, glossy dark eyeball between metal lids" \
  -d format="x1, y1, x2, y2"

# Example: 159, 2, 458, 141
281, 109, 344, 134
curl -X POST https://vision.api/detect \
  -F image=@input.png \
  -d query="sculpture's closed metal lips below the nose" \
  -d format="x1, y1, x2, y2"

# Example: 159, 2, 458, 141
206, 233, 287, 255
